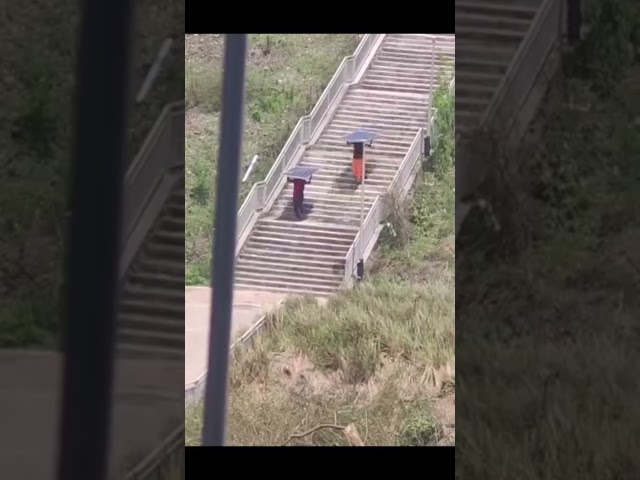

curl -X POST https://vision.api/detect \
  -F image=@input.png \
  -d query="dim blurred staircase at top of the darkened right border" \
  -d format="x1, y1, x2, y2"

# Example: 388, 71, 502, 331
456, 0, 542, 133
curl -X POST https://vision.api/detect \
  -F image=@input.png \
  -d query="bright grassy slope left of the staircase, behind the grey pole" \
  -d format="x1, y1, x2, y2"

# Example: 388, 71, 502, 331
185, 34, 359, 285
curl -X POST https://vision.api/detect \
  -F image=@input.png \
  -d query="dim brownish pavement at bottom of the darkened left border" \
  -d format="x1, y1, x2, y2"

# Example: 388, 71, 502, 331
0, 350, 184, 480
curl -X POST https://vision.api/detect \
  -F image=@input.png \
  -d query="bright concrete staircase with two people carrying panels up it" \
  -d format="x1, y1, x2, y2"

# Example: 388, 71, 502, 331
235, 34, 455, 295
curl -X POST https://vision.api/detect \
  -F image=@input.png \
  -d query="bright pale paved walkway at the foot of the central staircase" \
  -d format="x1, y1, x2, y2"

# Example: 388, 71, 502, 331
184, 287, 286, 385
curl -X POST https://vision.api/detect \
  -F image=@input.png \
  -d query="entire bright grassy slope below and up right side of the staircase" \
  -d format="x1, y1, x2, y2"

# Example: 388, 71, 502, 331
186, 70, 455, 445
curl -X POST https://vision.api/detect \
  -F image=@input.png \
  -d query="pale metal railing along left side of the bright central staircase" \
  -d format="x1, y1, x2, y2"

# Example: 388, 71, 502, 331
236, 34, 384, 254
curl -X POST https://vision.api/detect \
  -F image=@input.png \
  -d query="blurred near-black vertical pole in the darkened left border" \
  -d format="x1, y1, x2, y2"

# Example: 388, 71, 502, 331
58, 0, 132, 480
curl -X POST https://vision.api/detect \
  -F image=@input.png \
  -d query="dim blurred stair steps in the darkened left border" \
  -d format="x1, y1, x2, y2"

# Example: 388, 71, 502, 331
117, 172, 184, 360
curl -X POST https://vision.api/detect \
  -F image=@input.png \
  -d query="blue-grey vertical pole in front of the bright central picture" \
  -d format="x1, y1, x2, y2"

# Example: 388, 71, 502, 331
202, 34, 247, 446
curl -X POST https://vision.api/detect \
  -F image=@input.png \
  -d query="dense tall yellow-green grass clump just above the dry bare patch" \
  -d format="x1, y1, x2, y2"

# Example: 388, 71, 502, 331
258, 272, 454, 383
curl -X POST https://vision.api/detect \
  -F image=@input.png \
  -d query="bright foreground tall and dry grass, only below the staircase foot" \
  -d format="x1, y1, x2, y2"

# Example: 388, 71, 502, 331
187, 272, 455, 445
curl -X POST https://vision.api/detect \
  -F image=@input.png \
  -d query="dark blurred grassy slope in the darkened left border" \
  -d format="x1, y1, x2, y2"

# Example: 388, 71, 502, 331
0, 0, 184, 348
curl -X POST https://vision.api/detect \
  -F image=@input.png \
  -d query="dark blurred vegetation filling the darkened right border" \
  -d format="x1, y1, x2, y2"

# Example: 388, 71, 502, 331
456, 0, 640, 480
